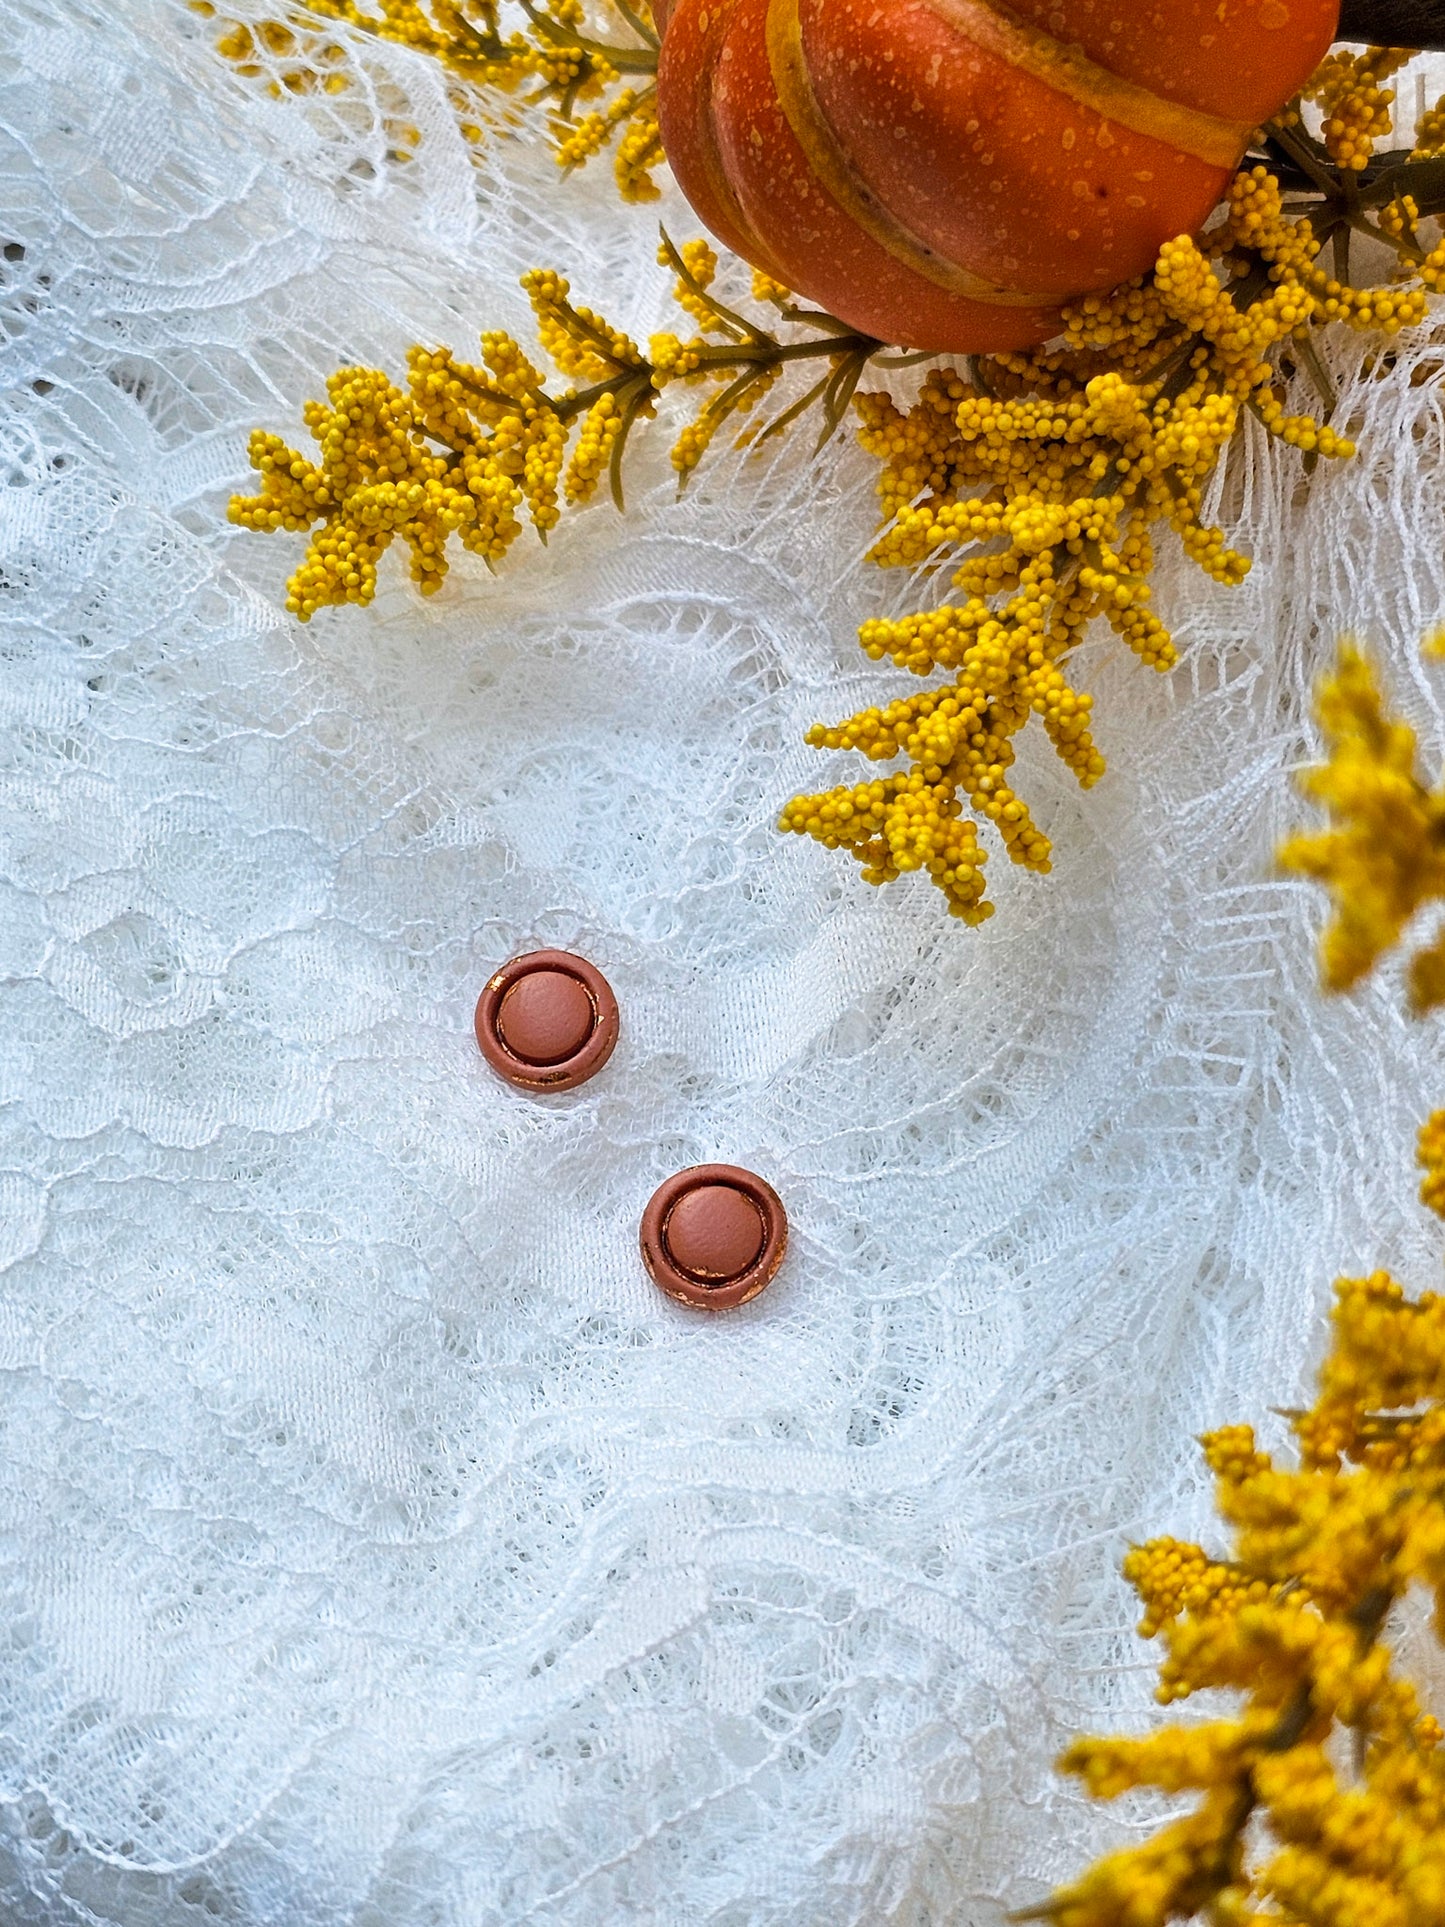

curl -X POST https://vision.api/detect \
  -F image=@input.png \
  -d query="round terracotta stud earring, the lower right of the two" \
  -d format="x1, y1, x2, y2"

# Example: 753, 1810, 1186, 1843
642, 1164, 788, 1310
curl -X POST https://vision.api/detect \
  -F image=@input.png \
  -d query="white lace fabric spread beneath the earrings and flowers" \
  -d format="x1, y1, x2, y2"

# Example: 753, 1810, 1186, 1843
0, 0, 1445, 1927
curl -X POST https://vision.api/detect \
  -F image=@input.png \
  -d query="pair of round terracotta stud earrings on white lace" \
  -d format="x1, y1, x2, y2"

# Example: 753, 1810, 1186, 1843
476, 950, 788, 1312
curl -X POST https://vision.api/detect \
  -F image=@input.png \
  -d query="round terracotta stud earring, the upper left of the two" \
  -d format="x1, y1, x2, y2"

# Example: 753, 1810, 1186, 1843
476, 950, 618, 1091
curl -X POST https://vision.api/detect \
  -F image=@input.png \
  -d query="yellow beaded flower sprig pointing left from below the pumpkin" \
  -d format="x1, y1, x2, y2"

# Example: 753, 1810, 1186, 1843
229, 237, 880, 608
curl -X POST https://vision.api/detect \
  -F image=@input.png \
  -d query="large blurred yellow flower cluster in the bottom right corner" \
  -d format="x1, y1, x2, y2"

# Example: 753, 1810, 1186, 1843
1021, 1202, 1445, 1927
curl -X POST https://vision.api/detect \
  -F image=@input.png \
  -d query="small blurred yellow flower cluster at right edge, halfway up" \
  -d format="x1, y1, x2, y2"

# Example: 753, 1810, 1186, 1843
1279, 644, 1445, 1012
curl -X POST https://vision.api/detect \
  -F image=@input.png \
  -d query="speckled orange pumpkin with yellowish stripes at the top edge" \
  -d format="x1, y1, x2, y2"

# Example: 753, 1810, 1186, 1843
653, 0, 1339, 353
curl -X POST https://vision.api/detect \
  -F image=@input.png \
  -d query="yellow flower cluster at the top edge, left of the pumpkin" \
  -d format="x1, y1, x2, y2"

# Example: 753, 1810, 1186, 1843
209, 0, 663, 200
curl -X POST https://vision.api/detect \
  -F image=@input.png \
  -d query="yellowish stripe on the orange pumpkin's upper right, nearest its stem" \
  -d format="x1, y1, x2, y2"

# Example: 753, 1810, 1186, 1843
919, 0, 1254, 172
